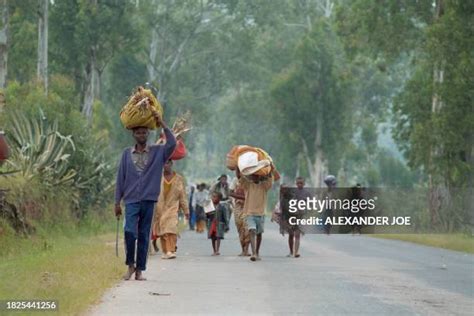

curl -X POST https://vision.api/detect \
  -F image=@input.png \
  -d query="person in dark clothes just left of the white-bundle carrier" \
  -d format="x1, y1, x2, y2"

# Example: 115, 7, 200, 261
206, 192, 228, 256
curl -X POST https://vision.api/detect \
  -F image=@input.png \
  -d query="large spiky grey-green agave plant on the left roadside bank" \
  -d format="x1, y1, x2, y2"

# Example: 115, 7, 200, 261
7, 113, 76, 186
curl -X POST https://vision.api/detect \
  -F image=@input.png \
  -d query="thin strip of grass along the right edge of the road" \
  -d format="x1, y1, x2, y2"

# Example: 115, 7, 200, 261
369, 233, 474, 254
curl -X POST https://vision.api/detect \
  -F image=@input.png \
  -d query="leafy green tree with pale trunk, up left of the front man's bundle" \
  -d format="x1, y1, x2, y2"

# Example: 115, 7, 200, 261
51, 0, 140, 122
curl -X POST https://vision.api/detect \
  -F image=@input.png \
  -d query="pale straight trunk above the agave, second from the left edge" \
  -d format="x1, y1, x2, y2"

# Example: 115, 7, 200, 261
37, 0, 49, 94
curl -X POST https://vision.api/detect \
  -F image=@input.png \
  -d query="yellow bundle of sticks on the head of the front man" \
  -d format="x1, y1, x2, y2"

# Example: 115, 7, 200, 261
120, 87, 163, 129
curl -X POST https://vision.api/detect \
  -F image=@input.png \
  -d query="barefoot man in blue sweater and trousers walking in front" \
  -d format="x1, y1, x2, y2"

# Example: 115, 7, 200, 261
115, 113, 176, 281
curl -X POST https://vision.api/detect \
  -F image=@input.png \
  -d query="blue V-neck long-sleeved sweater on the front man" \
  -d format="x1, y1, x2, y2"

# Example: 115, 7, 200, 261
115, 128, 176, 204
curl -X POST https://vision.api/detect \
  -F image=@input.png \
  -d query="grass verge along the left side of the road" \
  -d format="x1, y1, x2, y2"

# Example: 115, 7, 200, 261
0, 218, 124, 315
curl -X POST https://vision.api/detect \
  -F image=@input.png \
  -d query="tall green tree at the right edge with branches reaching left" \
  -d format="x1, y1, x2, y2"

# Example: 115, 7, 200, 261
338, 0, 474, 230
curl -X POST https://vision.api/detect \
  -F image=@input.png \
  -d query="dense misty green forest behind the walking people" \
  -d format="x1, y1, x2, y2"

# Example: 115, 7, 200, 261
0, 0, 474, 232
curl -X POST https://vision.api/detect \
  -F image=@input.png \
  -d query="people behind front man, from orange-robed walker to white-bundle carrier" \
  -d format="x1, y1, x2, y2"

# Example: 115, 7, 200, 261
152, 169, 273, 261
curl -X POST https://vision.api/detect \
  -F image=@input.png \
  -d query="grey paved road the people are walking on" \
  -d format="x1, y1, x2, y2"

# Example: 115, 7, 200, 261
90, 222, 474, 315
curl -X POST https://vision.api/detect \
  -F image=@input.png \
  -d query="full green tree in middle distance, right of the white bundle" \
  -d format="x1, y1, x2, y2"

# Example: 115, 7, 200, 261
273, 21, 352, 186
